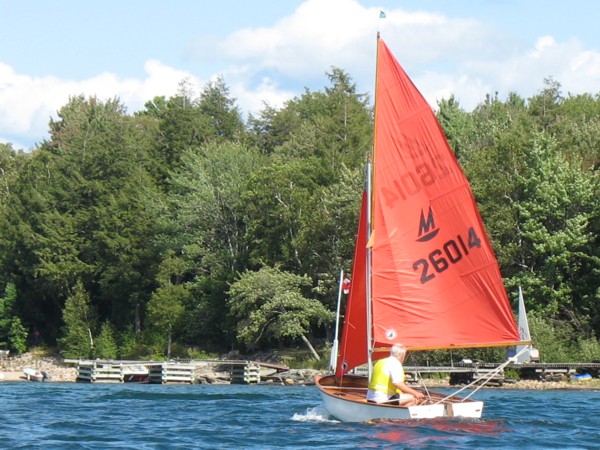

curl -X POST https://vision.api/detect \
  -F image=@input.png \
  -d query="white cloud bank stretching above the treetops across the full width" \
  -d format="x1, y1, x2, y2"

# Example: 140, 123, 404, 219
0, 0, 600, 148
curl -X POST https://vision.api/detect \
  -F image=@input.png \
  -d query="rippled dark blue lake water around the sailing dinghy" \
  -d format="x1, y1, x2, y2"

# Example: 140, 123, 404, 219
0, 382, 600, 449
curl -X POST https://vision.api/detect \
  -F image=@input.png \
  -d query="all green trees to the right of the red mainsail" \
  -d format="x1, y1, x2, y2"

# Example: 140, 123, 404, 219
454, 86, 600, 335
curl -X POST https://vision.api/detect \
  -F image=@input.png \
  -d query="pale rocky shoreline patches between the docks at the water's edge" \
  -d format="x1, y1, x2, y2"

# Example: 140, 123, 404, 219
0, 354, 600, 390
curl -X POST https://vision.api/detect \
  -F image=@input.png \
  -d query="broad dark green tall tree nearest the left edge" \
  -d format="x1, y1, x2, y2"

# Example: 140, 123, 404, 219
2, 97, 166, 342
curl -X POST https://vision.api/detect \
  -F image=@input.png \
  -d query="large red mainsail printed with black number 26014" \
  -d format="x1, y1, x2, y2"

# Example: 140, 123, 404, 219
371, 39, 519, 349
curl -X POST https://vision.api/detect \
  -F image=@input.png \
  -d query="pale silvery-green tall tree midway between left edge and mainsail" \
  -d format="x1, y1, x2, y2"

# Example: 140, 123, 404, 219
158, 142, 261, 346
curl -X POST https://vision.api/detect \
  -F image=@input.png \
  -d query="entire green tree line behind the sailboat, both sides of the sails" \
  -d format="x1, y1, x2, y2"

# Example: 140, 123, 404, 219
0, 72, 600, 364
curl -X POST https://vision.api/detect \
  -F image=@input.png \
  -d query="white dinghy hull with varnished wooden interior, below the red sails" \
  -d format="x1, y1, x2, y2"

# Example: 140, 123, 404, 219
315, 375, 483, 422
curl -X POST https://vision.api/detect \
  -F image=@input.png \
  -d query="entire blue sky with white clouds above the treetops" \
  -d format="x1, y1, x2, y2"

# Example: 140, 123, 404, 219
0, 0, 600, 151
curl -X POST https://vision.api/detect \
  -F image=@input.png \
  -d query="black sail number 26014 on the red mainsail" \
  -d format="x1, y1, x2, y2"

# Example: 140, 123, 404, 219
413, 227, 481, 284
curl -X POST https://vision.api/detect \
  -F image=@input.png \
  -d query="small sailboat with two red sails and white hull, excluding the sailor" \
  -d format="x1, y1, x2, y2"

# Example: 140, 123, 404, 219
315, 35, 522, 422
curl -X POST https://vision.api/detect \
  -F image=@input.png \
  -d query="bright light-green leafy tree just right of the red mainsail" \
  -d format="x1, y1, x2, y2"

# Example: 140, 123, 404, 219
511, 136, 598, 326
